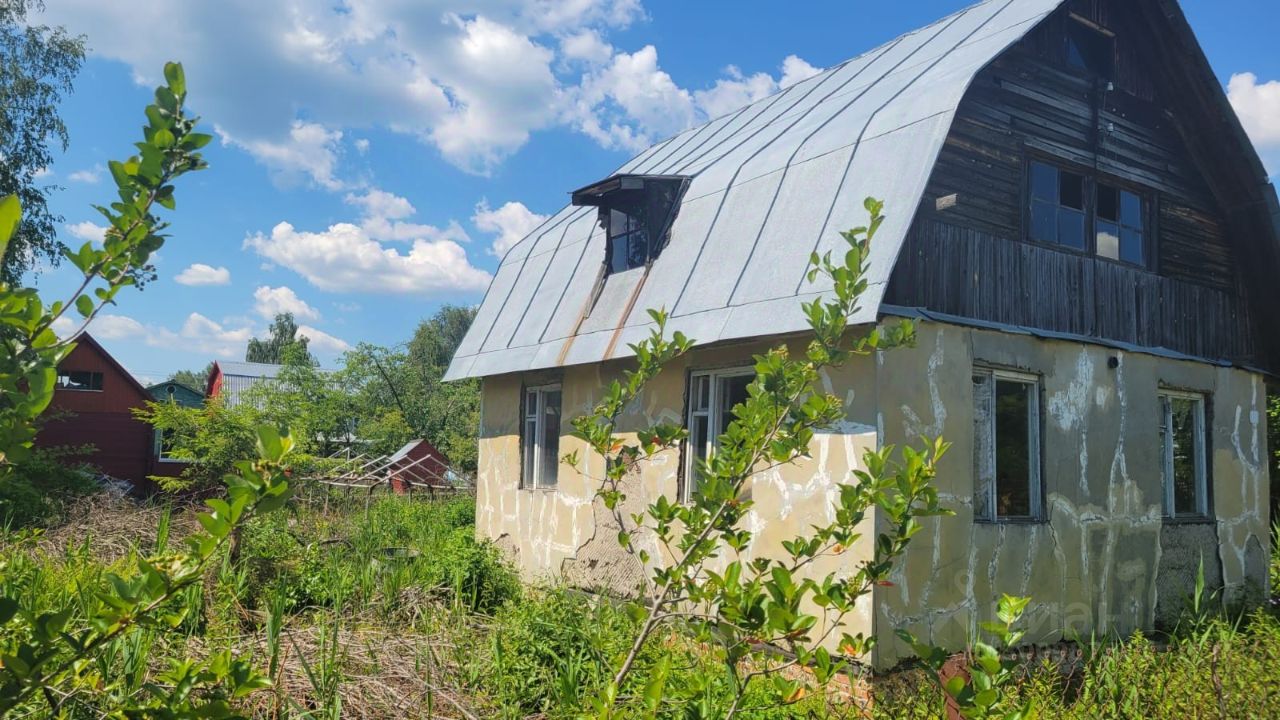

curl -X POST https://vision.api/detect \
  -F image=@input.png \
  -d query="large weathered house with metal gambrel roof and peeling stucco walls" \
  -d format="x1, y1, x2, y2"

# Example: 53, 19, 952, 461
448, 0, 1280, 666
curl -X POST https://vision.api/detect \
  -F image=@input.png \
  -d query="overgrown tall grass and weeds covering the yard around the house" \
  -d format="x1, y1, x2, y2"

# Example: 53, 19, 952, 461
0, 486, 1280, 720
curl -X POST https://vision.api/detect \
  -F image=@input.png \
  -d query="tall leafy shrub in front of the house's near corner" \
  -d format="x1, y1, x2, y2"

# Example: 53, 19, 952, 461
566, 199, 948, 717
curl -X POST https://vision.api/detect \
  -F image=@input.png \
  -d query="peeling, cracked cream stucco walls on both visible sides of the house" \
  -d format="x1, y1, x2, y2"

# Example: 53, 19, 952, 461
477, 316, 1267, 667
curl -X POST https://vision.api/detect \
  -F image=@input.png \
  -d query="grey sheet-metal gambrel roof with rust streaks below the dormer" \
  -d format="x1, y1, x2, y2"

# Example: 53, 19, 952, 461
447, 0, 1064, 379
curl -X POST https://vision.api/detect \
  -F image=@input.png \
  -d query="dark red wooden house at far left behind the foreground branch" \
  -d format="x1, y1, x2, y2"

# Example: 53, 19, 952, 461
36, 333, 165, 489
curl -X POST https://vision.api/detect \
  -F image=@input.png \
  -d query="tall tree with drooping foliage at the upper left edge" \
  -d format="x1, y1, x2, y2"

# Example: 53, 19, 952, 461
0, 0, 84, 286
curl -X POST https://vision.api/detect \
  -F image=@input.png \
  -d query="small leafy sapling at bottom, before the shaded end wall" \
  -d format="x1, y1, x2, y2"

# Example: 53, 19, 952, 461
897, 594, 1036, 720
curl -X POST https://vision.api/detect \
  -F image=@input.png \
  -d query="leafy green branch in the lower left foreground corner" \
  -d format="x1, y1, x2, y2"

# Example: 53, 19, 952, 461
0, 428, 293, 717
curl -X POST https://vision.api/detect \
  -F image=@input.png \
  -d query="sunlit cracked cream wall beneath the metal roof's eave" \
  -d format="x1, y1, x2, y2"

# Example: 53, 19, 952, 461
476, 341, 877, 645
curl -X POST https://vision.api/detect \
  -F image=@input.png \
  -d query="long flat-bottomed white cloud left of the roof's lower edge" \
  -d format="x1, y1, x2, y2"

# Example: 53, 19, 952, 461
244, 223, 490, 295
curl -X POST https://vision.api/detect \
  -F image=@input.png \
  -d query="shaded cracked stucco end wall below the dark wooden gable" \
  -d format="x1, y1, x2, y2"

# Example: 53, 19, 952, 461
876, 323, 1267, 666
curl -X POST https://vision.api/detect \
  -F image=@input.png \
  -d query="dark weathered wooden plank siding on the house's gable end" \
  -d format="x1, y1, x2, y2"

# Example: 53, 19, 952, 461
886, 0, 1256, 363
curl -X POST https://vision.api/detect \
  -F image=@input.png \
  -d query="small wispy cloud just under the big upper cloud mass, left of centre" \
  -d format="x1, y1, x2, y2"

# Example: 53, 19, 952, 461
216, 120, 343, 190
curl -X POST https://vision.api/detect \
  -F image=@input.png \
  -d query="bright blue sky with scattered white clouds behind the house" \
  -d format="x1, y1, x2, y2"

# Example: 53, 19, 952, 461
27, 0, 1280, 380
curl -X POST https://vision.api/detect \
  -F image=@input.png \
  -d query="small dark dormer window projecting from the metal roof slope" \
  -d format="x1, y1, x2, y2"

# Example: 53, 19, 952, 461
573, 176, 689, 274
